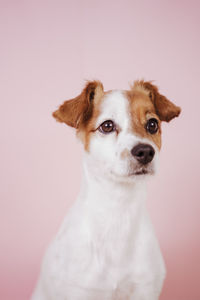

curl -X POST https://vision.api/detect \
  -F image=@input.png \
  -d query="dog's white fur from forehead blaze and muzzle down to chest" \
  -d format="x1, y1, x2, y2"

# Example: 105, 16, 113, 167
32, 91, 165, 300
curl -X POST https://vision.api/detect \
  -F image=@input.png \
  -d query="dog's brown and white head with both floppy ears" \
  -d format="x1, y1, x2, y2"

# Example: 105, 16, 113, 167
53, 81, 180, 181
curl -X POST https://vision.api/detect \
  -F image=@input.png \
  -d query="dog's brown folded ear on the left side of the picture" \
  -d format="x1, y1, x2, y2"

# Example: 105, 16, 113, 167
53, 81, 103, 129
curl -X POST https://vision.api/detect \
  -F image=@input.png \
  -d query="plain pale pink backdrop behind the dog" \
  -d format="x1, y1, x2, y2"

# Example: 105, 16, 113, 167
0, 0, 200, 300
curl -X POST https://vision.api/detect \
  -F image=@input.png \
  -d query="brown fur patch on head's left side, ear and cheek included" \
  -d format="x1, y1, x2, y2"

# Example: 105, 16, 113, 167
53, 81, 104, 150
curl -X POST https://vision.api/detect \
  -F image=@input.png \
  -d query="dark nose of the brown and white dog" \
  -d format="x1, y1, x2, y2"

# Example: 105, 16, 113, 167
131, 144, 155, 165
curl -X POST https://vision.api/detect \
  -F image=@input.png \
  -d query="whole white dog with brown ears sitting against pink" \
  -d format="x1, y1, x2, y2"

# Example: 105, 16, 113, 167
32, 80, 181, 300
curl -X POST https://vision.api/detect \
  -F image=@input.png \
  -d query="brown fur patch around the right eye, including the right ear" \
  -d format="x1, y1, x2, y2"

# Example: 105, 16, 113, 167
126, 80, 181, 149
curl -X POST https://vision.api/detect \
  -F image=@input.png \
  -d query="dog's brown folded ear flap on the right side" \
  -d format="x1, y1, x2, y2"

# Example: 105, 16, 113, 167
142, 81, 181, 122
